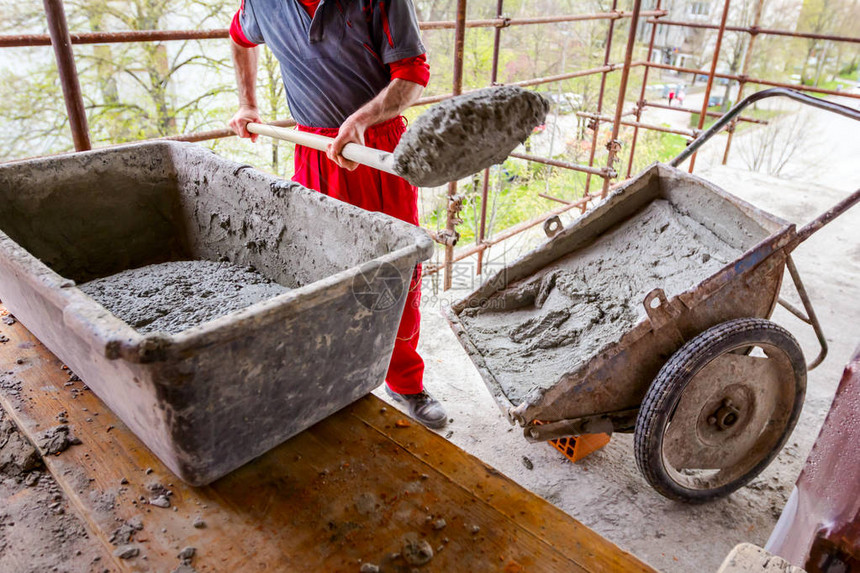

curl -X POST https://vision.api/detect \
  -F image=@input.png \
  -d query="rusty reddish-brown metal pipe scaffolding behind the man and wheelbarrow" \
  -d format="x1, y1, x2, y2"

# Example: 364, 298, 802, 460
0, 0, 860, 290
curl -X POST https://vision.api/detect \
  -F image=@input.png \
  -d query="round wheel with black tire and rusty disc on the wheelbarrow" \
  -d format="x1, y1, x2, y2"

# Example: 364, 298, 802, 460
635, 318, 806, 503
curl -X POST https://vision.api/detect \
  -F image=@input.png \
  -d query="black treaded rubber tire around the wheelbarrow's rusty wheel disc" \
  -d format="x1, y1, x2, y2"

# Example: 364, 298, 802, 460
634, 318, 806, 503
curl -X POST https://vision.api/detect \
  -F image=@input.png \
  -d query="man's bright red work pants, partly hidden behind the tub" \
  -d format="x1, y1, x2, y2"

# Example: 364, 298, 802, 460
293, 117, 424, 394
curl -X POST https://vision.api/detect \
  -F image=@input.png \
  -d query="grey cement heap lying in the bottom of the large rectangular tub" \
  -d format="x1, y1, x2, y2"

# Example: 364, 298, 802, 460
80, 261, 289, 334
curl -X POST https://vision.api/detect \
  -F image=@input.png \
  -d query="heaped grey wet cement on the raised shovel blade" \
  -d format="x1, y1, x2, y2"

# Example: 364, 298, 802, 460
394, 86, 549, 187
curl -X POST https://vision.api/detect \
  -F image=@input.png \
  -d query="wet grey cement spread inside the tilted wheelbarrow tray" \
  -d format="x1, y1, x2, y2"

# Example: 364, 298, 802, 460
460, 199, 741, 404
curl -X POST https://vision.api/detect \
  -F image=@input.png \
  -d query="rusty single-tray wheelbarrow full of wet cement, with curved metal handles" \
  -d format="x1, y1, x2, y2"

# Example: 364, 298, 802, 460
447, 89, 860, 503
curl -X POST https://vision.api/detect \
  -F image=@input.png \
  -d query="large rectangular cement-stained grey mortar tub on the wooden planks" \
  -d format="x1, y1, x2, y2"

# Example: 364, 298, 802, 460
0, 142, 433, 485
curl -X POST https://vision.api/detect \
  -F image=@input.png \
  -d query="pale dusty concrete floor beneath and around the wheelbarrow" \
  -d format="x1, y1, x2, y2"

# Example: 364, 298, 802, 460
377, 91, 860, 572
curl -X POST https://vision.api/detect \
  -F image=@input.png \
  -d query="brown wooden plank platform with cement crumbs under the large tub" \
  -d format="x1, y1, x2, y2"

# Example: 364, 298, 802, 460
0, 307, 652, 573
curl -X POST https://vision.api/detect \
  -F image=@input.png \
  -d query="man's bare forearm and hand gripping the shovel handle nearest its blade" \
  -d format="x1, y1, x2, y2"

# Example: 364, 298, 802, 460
328, 79, 424, 171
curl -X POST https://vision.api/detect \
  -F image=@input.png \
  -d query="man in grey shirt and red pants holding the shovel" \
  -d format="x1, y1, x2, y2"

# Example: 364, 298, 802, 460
229, 0, 447, 428
